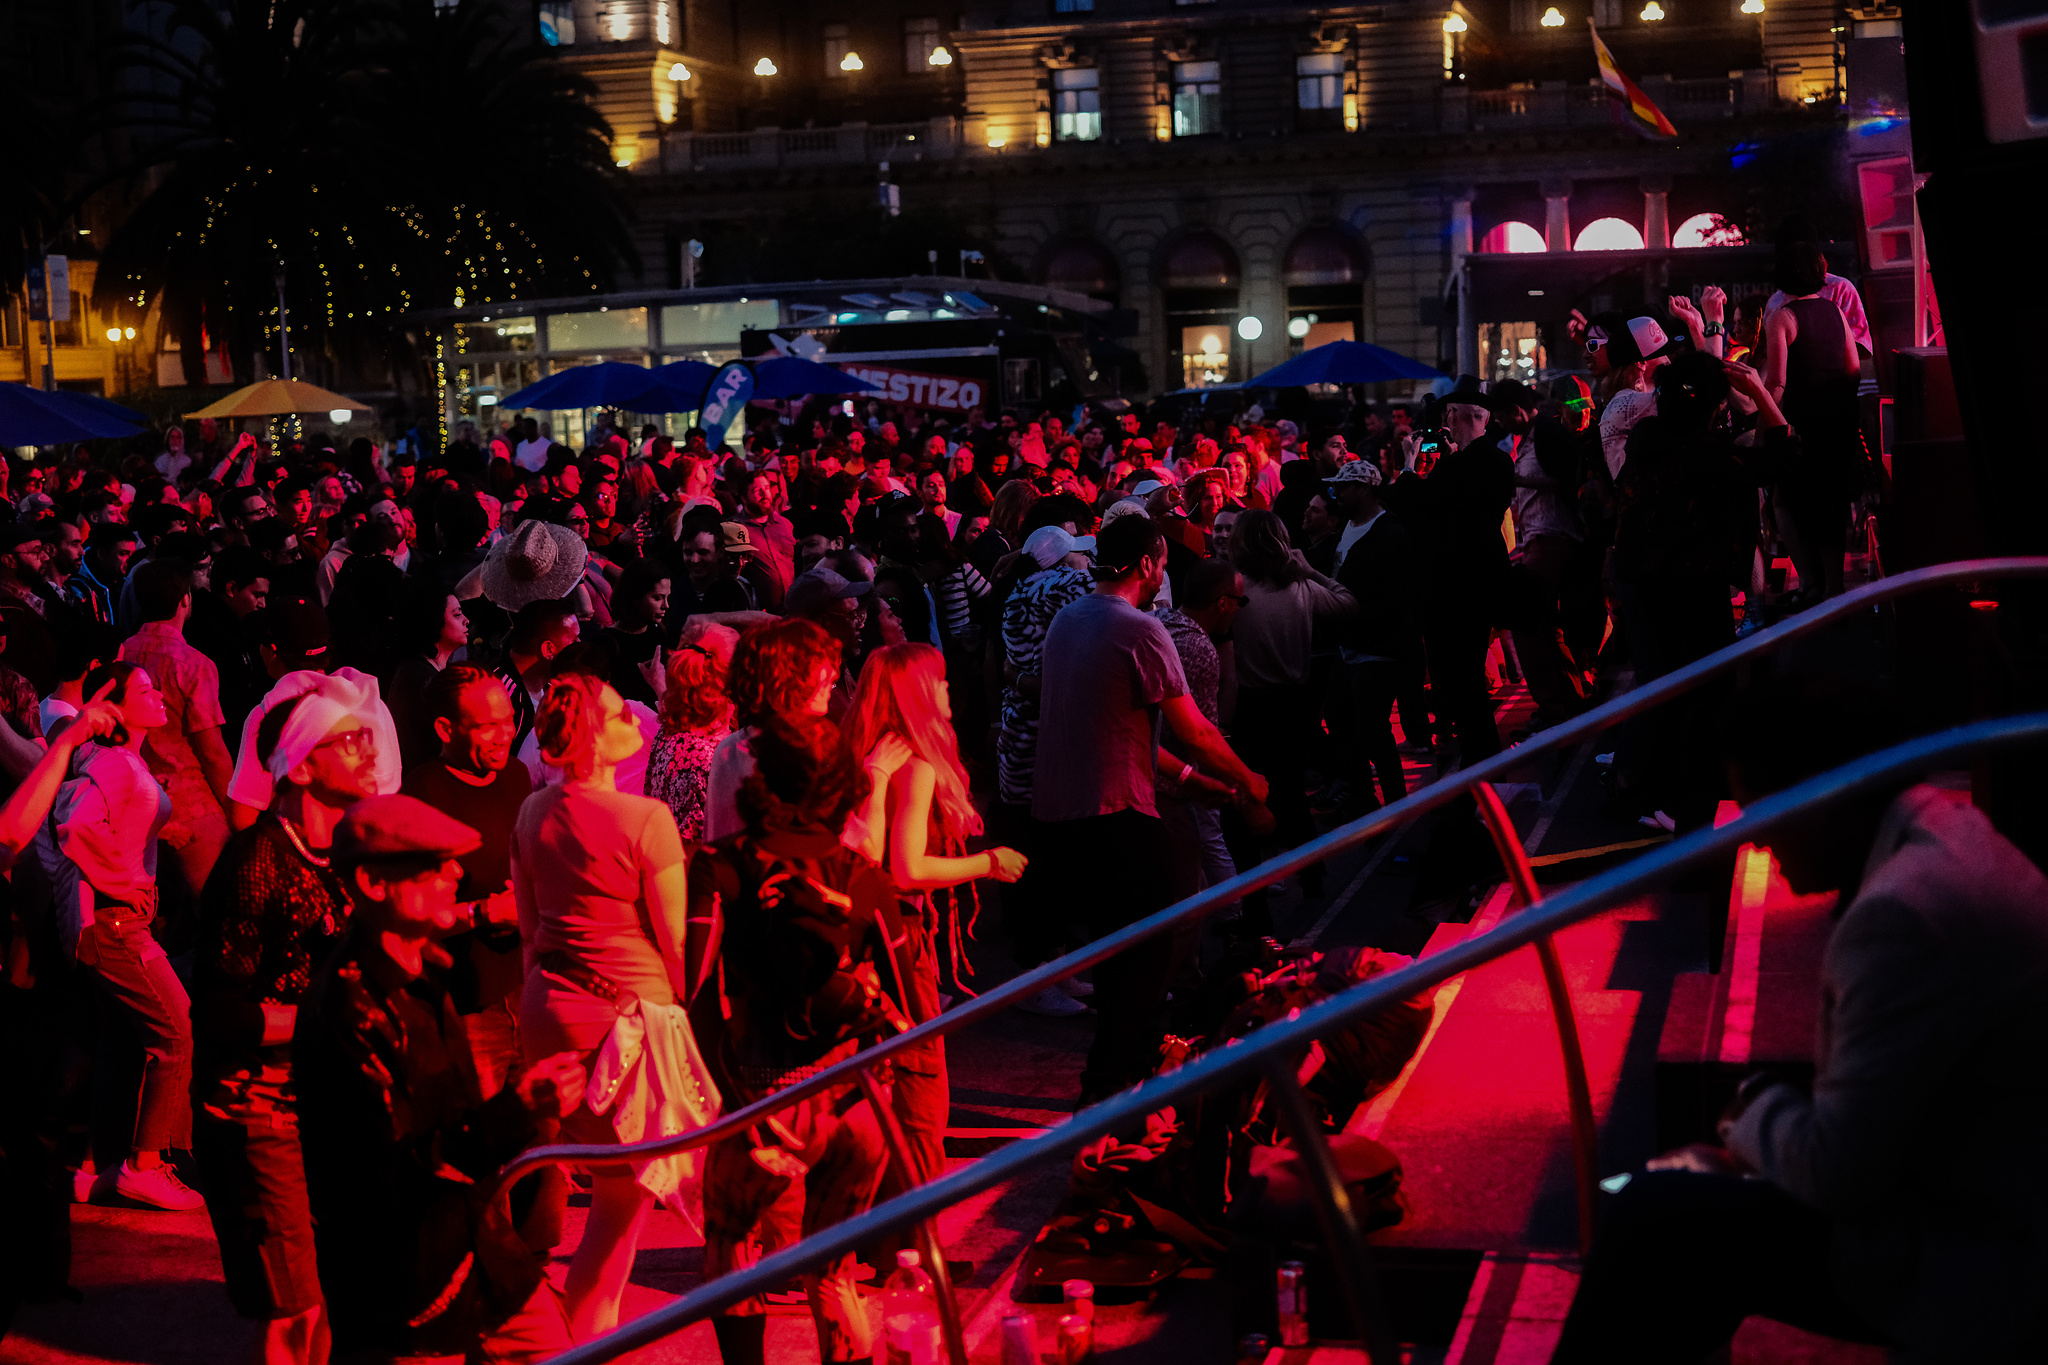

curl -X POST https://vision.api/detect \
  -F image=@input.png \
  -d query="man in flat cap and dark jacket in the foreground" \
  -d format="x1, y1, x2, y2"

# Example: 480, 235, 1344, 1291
291, 796, 584, 1365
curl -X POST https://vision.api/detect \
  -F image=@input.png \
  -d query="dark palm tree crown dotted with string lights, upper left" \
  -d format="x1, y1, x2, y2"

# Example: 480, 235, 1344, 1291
98, 0, 631, 383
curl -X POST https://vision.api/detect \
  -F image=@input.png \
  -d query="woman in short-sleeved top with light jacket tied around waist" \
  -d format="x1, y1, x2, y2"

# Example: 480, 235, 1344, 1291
512, 673, 719, 1340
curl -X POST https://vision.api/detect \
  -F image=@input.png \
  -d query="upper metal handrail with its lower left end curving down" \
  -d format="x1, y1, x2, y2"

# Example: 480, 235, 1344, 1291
498, 557, 2048, 1195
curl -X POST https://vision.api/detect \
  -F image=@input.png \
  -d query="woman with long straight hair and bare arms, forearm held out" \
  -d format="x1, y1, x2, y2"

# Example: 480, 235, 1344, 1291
844, 645, 1024, 1199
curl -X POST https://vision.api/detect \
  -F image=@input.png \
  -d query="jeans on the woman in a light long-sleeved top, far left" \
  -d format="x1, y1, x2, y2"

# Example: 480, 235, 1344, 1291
78, 907, 193, 1152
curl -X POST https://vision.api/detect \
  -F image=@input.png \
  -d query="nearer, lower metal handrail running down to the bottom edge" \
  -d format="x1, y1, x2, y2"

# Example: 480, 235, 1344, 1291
532, 712, 2048, 1365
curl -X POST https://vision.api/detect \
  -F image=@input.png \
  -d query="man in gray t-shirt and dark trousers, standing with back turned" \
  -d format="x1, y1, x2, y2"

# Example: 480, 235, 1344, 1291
1032, 516, 1266, 1105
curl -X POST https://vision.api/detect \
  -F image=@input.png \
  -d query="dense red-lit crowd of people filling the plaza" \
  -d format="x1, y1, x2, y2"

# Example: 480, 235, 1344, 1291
0, 224, 1868, 1365
